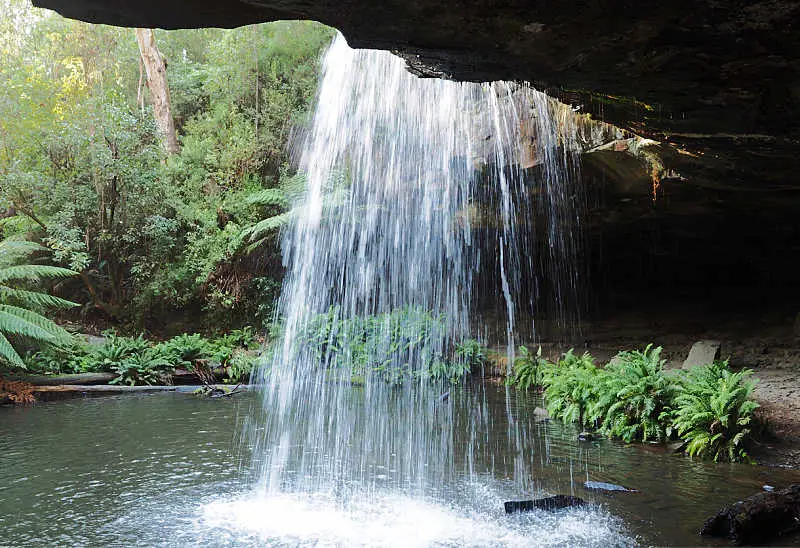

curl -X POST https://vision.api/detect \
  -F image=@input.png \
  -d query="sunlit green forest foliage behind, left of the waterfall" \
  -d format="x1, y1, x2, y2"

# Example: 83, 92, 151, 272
0, 2, 333, 328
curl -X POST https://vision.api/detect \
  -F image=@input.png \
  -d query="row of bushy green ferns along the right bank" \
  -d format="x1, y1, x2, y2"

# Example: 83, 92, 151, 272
536, 345, 758, 462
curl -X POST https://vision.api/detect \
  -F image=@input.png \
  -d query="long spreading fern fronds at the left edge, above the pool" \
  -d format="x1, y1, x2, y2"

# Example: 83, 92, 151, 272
0, 239, 78, 369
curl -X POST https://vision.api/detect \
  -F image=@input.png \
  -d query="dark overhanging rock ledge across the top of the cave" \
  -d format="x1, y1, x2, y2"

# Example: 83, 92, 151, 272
34, 0, 800, 150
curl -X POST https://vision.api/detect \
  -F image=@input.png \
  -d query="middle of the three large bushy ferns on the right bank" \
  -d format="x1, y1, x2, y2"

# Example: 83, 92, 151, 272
593, 345, 678, 442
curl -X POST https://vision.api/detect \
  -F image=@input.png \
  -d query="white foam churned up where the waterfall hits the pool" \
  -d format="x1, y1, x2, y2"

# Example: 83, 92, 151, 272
197, 494, 633, 547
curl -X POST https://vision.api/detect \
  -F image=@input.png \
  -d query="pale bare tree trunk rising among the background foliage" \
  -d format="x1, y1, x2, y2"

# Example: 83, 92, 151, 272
136, 29, 179, 154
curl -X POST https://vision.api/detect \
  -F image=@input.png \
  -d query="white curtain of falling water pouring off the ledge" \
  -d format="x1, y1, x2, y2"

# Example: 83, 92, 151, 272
247, 37, 636, 544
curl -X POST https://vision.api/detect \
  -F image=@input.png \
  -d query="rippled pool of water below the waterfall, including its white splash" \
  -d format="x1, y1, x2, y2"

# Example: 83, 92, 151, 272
0, 385, 800, 546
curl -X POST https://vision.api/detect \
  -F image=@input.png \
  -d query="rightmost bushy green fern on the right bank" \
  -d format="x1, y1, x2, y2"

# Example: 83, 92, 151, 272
674, 361, 759, 462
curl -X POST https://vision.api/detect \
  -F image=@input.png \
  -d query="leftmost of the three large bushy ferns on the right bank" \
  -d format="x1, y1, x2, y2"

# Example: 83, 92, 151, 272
544, 349, 603, 425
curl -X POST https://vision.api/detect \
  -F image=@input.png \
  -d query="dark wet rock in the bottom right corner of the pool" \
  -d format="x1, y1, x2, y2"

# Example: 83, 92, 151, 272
700, 483, 800, 544
